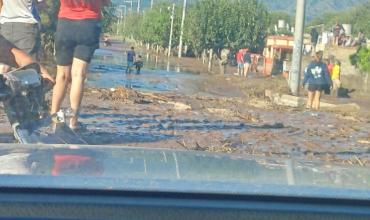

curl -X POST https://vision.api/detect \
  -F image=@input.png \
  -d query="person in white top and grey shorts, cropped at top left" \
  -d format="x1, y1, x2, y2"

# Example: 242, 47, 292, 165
0, 0, 43, 60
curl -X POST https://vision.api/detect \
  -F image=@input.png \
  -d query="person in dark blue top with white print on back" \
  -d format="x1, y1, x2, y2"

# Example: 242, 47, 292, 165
303, 51, 333, 110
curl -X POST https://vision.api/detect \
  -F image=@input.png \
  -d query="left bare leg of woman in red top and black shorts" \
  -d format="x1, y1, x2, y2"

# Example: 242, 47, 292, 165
51, 66, 71, 114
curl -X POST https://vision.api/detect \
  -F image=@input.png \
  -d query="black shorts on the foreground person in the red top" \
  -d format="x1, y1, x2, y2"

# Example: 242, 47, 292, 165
55, 19, 101, 66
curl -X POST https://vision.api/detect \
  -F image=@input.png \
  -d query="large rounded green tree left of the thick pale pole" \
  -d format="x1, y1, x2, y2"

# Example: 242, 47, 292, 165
186, 0, 269, 53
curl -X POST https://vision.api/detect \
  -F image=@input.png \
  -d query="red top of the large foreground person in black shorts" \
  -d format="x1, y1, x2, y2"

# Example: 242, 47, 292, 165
58, 0, 110, 20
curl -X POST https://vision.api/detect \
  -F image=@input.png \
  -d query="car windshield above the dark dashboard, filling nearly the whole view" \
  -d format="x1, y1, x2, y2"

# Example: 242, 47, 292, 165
0, 0, 370, 200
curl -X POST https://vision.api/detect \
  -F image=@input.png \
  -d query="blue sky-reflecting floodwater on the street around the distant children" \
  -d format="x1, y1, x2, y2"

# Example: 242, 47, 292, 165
87, 49, 205, 94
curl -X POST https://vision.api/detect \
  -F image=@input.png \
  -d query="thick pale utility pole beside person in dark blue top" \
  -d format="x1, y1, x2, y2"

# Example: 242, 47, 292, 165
289, 0, 306, 96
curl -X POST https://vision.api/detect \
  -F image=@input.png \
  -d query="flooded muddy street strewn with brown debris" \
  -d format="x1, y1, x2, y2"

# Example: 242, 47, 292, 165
0, 46, 370, 166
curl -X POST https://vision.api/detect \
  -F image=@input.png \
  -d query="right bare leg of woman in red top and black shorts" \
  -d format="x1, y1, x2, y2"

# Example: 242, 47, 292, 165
70, 58, 88, 127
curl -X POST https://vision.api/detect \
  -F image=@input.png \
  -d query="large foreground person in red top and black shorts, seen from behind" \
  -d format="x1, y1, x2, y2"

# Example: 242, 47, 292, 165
51, 0, 110, 129
